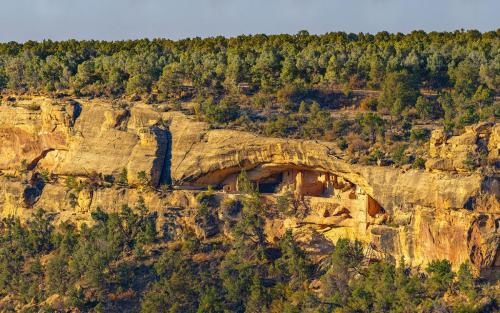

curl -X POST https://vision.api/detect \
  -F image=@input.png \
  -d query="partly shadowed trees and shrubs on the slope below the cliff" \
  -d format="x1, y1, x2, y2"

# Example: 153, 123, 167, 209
0, 182, 498, 313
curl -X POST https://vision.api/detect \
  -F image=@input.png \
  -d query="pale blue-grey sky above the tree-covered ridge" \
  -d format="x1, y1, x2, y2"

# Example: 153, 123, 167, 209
0, 0, 500, 42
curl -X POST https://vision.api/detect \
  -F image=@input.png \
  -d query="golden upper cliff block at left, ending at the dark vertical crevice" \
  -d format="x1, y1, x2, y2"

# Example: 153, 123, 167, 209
0, 98, 167, 185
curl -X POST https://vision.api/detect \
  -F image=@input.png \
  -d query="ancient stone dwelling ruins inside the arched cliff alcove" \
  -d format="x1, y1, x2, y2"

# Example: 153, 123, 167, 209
196, 164, 387, 229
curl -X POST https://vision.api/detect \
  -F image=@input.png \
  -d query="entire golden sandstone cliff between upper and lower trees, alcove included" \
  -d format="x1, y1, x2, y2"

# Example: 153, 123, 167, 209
0, 98, 500, 269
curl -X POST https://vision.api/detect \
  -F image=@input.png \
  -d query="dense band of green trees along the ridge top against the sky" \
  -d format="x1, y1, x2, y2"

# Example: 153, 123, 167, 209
0, 30, 500, 124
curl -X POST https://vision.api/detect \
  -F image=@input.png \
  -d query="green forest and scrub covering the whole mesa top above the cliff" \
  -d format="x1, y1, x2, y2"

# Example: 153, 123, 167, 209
0, 30, 500, 169
